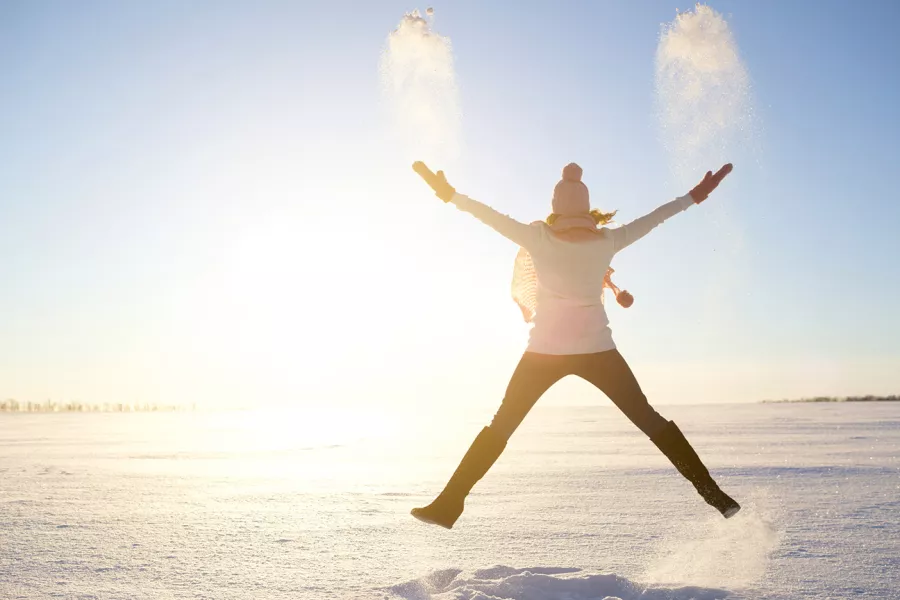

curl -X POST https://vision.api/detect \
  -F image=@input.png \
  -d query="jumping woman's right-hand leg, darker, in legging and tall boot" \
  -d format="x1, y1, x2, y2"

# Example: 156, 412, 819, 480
576, 350, 741, 518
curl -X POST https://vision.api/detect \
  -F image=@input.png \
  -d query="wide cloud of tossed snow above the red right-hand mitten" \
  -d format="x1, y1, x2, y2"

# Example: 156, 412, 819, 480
655, 4, 754, 187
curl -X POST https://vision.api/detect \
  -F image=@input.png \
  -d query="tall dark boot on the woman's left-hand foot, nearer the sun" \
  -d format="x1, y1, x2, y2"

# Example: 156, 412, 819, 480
410, 427, 506, 529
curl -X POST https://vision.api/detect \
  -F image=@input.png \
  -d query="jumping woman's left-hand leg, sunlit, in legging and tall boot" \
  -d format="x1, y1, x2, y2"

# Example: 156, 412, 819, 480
412, 352, 571, 529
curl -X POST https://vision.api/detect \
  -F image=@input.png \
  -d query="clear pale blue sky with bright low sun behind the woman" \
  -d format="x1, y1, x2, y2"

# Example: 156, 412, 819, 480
0, 0, 900, 414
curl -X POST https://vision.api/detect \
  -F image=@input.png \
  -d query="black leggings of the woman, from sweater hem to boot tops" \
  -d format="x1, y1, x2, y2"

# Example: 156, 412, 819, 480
491, 350, 667, 439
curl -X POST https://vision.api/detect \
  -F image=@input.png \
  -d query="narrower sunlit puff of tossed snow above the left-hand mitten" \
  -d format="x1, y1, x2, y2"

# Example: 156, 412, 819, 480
380, 8, 461, 164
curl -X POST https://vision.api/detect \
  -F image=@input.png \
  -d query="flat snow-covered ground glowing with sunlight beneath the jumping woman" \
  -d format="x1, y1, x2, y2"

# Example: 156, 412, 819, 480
0, 403, 900, 600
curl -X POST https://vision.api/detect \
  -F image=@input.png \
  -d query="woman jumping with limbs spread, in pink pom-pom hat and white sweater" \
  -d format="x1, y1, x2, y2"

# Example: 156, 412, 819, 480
412, 162, 740, 529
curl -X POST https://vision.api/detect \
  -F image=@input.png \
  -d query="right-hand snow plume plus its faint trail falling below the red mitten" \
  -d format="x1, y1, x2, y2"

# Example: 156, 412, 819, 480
655, 4, 758, 328
